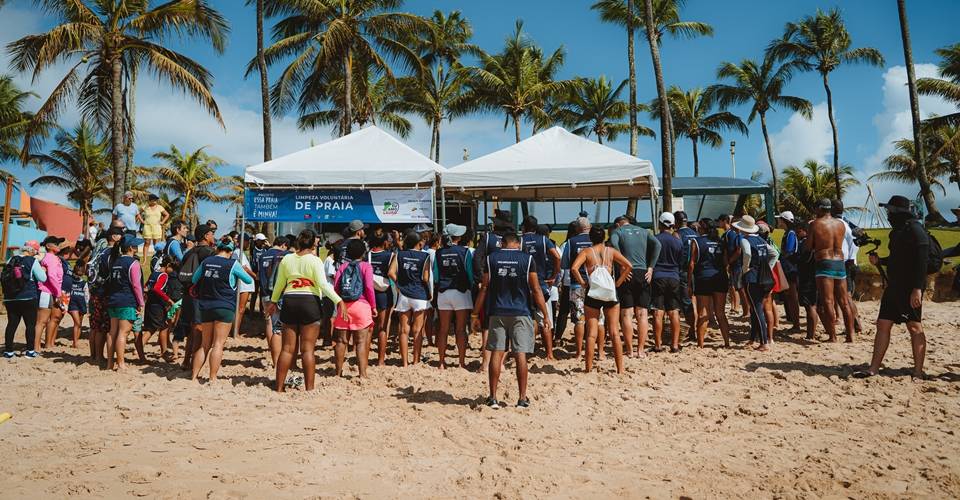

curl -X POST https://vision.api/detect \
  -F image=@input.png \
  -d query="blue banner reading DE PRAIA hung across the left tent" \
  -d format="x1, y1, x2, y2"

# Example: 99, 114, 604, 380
243, 189, 433, 223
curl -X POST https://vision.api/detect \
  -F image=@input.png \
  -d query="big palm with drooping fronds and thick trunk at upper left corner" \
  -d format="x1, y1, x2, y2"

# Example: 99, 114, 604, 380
7, 0, 229, 203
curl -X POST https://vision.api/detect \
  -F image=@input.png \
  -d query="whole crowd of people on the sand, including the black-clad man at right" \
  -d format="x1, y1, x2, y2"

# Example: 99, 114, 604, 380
3, 193, 944, 407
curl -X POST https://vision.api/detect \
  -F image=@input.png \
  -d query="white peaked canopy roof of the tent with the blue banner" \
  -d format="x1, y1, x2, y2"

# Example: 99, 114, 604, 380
244, 126, 442, 187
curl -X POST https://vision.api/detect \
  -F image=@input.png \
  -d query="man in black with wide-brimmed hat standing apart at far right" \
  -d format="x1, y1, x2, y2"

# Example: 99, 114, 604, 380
854, 196, 930, 379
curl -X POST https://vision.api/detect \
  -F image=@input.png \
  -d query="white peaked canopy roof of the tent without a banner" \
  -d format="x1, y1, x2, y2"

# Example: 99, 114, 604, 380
442, 127, 657, 198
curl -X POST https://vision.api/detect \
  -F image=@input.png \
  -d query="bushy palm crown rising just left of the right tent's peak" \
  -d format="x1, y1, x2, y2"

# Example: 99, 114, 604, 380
469, 20, 577, 142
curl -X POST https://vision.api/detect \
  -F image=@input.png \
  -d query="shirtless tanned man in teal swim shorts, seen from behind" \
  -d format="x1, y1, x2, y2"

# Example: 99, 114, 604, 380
806, 199, 853, 342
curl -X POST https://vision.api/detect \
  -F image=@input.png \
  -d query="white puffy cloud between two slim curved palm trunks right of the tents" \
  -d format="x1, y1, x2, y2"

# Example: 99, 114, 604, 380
761, 102, 833, 170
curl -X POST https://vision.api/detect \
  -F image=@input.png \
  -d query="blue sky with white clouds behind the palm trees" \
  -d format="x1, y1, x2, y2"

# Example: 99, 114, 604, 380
0, 0, 960, 230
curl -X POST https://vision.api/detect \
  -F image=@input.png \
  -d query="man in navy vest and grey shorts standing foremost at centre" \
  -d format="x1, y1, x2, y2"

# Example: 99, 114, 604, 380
474, 232, 553, 409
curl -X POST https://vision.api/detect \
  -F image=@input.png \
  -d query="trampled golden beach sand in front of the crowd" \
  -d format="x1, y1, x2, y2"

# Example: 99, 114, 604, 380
0, 303, 960, 498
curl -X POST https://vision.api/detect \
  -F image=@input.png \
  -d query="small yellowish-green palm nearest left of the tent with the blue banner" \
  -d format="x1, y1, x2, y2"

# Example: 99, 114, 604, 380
152, 145, 226, 226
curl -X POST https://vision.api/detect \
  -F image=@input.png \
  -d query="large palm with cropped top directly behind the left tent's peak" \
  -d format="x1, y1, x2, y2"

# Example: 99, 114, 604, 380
262, 0, 430, 135
